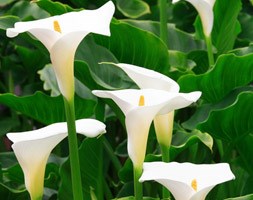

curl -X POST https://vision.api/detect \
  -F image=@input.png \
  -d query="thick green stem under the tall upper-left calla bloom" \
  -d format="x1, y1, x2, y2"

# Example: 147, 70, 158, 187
64, 98, 83, 200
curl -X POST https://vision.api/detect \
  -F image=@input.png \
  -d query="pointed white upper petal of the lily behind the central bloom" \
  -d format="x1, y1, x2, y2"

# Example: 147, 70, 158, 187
114, 63, 179, 92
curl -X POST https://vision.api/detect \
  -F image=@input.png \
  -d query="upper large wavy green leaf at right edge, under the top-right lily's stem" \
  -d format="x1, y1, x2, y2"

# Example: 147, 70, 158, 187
178, 54, 253, 102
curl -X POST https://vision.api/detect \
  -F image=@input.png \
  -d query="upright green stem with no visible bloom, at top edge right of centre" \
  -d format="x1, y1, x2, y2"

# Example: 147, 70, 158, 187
159, 0, 169, 47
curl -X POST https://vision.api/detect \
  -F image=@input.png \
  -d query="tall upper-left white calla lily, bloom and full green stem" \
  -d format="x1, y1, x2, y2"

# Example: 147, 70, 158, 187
7, 1, 115, 200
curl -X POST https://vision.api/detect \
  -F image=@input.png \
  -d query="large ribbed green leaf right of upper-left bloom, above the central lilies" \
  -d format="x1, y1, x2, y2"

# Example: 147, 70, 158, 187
95, 20, 169, 73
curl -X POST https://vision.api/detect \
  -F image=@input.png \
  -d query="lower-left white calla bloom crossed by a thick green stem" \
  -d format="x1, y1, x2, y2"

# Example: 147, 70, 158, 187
7, 119, 106, 200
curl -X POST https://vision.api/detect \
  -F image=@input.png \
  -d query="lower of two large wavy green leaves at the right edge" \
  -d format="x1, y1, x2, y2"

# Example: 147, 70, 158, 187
197, 91, 253, 142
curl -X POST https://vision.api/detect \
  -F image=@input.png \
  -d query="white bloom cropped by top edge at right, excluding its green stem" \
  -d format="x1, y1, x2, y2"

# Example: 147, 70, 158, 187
172, 0, 215, 37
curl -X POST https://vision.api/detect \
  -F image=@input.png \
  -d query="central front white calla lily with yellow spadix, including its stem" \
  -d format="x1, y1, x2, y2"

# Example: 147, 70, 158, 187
92, 89, 201, 199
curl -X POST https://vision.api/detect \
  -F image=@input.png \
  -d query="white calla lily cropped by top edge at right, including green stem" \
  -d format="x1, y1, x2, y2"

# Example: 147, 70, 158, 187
172, 0, 215, 66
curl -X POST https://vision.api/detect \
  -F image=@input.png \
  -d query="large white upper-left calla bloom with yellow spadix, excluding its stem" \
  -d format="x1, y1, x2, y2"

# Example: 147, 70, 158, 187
7, 1, 115, 100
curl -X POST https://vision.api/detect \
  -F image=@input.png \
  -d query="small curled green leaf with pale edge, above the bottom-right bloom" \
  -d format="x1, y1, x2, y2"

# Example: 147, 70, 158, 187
170, 129, 213, 158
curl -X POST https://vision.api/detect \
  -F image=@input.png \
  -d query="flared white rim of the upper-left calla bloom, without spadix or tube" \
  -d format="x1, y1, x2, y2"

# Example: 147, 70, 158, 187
6, 1, 115, 51
